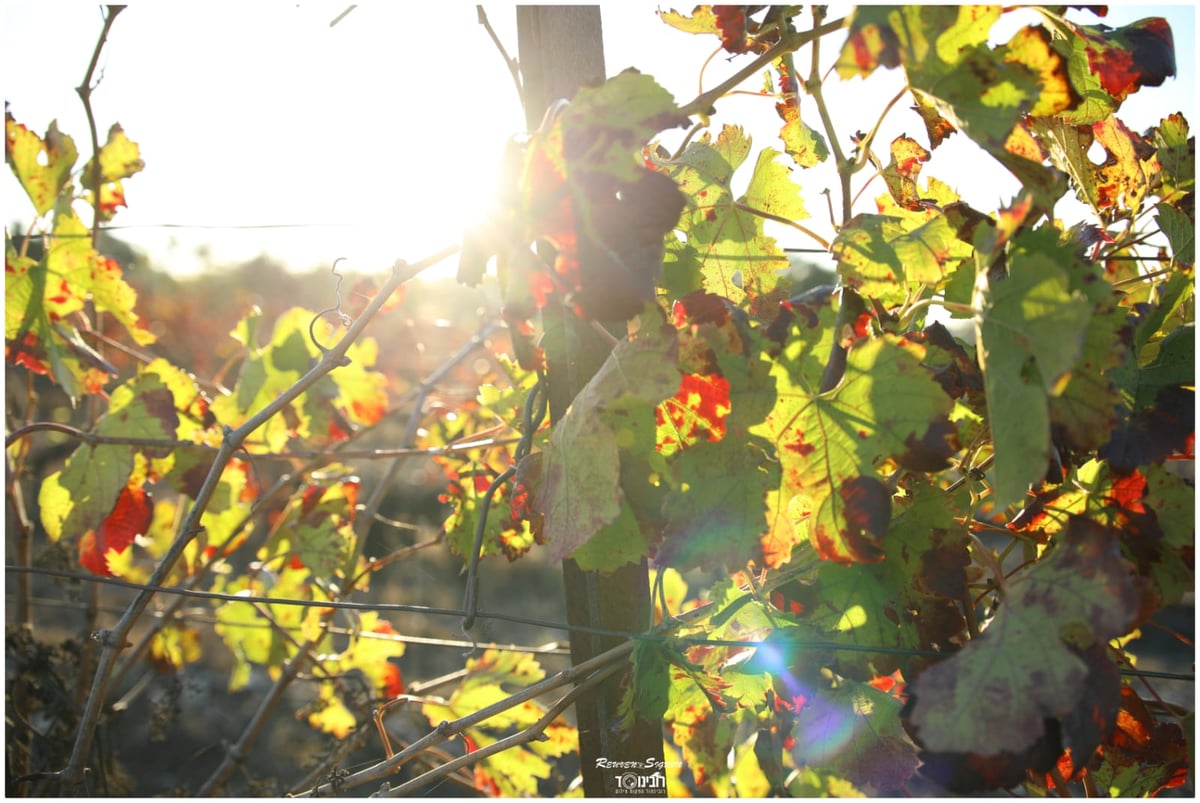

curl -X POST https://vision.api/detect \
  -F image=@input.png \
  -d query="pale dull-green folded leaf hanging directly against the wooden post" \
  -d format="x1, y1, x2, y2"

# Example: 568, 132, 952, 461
533, 326, 679, 561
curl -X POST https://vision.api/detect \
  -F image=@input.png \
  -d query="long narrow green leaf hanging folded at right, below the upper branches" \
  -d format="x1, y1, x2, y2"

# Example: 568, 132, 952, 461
974, 229, 1092, 508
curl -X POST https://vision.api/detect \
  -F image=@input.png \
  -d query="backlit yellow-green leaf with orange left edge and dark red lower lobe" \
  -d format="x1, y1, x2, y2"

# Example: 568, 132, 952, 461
750, 335, 953, 567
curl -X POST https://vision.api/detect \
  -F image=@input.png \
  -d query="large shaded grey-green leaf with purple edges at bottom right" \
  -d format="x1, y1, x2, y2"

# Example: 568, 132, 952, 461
906, 517, 1138, 756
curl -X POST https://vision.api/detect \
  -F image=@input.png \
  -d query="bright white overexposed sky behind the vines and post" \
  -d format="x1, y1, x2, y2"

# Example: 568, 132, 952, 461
0, 0, 1196, 275
